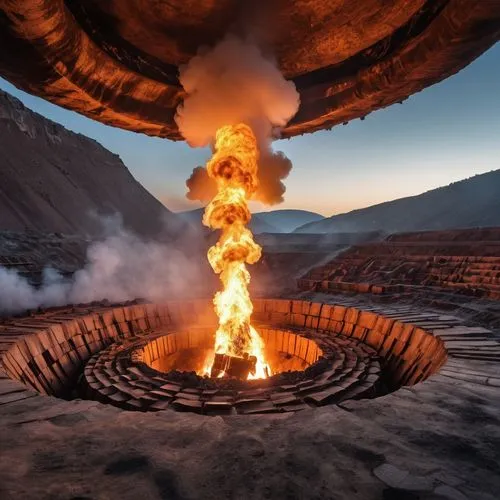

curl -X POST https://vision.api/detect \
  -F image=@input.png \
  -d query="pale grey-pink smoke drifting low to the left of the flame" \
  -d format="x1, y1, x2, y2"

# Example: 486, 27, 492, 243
0, 220, 210, 314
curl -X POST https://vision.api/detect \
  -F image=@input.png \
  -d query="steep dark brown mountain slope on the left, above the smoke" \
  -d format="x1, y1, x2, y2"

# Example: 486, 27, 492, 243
0, 90, 181, 236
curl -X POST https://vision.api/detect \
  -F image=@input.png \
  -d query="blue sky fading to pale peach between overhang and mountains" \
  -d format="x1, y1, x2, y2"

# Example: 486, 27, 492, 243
0, 44, 500, 216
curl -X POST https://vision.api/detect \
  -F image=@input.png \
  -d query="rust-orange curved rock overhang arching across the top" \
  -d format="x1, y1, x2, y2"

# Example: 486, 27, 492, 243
0, 0, 500, 140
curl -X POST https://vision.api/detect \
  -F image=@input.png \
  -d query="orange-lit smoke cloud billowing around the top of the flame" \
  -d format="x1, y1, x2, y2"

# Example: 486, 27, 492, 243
175, 36, 299, 205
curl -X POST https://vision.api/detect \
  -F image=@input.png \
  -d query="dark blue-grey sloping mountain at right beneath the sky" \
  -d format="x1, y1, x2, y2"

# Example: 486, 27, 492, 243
295, 170, 500, 233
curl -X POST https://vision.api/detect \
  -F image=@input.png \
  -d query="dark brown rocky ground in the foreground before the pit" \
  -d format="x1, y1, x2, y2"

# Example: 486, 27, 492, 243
0, 375, 500, 500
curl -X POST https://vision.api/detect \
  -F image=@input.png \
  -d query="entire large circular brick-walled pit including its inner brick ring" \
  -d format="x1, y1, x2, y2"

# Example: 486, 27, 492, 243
2, 299, 447, 415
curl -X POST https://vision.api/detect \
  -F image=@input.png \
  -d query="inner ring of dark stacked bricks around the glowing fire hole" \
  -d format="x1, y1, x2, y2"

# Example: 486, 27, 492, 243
83, 327, 380, 414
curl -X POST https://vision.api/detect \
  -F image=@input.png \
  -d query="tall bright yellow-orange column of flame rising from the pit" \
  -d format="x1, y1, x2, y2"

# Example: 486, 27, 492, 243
203, 124, 271, 379
